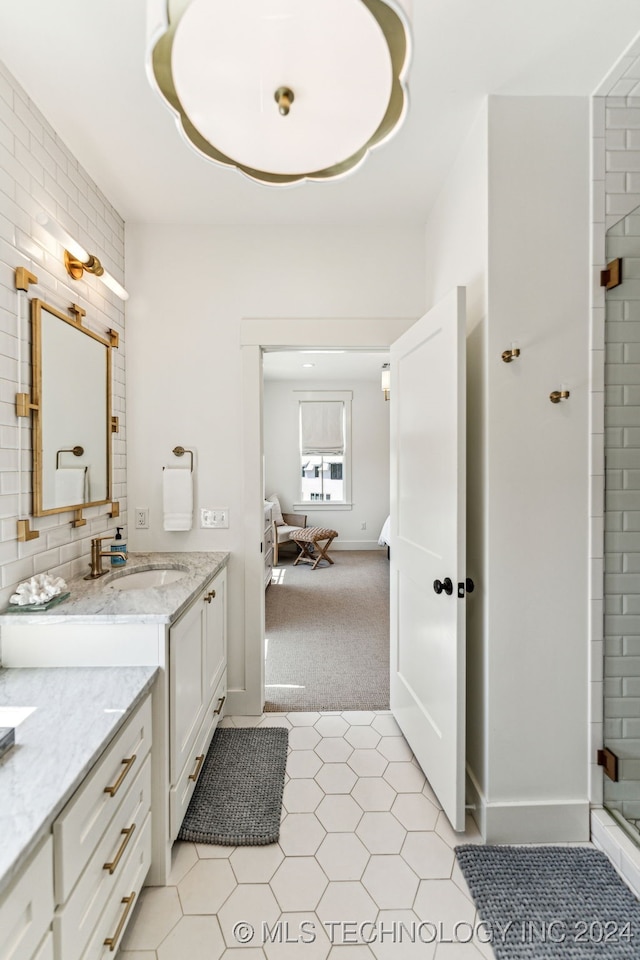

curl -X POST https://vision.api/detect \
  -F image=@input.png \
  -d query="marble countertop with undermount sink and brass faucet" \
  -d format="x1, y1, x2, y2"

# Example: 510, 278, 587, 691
0, 552, 229, 624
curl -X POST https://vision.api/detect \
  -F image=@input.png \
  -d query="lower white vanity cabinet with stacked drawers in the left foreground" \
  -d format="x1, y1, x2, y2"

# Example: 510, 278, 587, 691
0, 694, 152, 960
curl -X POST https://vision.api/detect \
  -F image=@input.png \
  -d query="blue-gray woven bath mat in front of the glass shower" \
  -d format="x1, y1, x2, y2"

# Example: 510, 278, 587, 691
456, 844, 640, 960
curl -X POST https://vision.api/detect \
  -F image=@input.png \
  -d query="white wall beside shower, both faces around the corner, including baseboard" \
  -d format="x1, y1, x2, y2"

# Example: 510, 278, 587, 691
426, 97, 589, 841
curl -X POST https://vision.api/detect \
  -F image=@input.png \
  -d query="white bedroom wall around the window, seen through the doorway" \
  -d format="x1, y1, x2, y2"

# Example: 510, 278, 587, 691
264, 380, 389, 550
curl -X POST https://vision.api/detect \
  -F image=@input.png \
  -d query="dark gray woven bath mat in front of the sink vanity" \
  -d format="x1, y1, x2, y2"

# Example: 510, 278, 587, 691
178, 727, 289, 846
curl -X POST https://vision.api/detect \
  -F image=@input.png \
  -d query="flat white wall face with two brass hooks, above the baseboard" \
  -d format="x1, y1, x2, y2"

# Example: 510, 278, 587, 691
487, 97, 589, 832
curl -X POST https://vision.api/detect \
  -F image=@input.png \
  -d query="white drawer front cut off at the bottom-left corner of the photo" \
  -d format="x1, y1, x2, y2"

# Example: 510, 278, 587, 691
0, 837, 53, 960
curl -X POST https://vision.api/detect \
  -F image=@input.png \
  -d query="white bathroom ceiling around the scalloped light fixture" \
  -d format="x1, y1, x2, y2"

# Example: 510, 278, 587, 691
0, 0, 640, 225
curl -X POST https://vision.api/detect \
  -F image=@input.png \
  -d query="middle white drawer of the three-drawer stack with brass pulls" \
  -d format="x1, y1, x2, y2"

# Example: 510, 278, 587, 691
53, 756, 151, 960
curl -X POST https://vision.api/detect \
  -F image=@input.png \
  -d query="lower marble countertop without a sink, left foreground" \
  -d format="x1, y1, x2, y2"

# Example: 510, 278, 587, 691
0, 667, 158, 892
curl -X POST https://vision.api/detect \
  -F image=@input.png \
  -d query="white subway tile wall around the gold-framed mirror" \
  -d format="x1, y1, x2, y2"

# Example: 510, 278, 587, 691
0, 63, 126, 609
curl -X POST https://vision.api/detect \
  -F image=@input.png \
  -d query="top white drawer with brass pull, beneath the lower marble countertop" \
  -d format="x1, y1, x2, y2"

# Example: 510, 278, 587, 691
53, 696, 151, 903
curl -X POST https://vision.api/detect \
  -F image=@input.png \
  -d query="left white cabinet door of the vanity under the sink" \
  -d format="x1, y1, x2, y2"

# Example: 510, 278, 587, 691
169, 591, 206, 784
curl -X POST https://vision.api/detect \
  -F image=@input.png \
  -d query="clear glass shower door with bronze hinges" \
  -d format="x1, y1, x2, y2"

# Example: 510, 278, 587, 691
604, 208, 640, 842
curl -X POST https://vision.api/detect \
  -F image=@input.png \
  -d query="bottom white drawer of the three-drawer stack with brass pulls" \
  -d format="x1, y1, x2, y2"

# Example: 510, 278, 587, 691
78, 814, 151, 960
